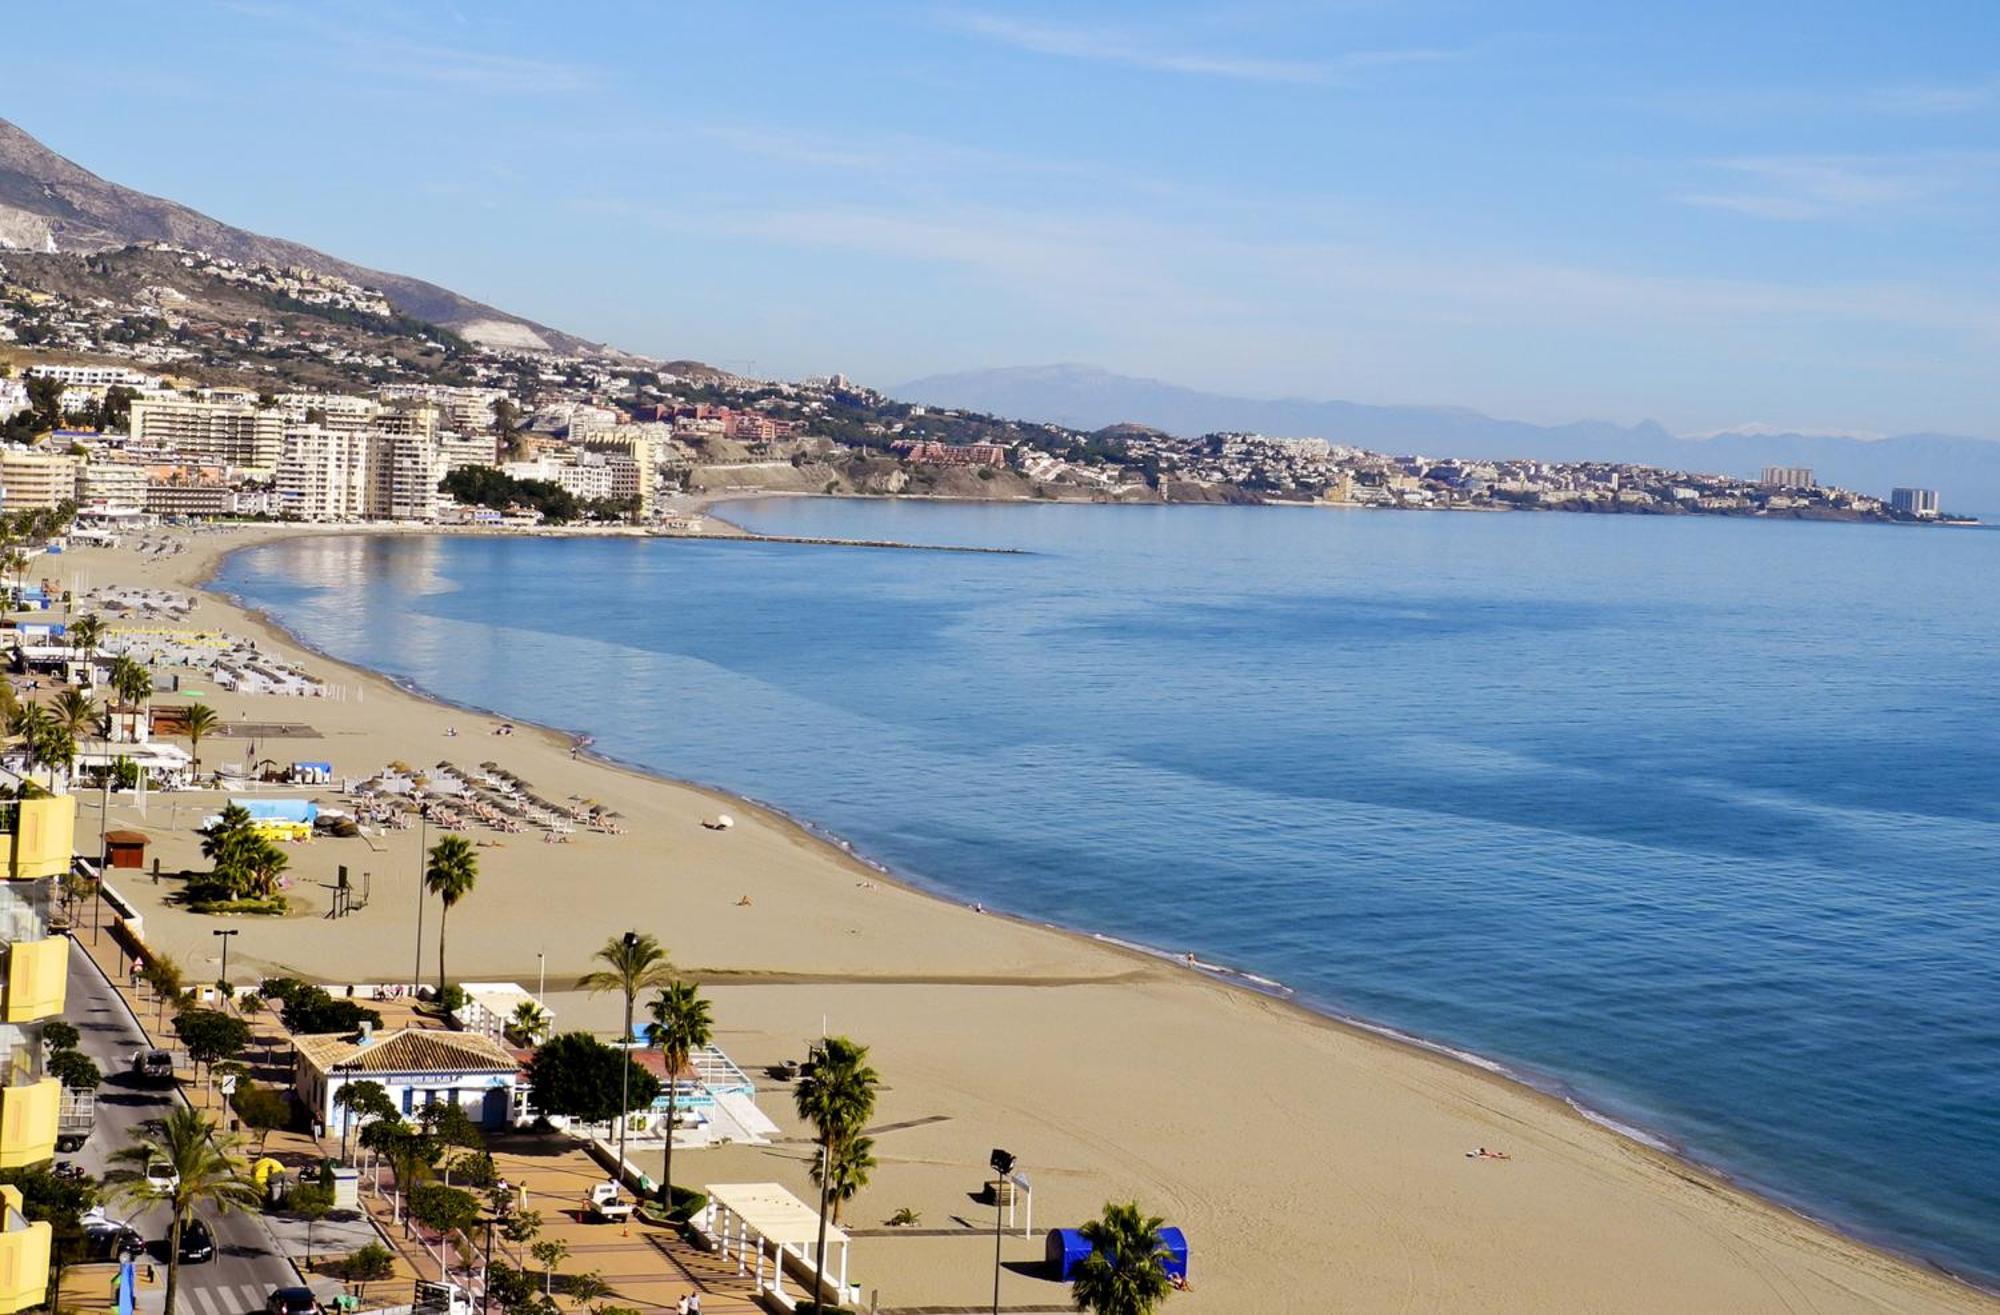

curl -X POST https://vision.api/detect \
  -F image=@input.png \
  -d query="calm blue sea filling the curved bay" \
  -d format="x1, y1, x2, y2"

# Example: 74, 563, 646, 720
222, 500, 2000, 1281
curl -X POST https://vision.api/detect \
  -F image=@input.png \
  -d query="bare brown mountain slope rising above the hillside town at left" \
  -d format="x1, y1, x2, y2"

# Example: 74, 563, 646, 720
0, 118, 608, 354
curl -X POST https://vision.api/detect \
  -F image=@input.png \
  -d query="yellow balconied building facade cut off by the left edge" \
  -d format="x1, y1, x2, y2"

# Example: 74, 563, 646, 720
0, 795, 76, 1315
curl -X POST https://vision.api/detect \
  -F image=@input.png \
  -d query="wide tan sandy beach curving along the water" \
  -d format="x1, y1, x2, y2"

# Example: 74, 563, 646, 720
54, 528, 2000, 1315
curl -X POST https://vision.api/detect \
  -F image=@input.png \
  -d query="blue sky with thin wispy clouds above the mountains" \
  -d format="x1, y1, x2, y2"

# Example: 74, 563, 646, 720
0, 0, 2000, 438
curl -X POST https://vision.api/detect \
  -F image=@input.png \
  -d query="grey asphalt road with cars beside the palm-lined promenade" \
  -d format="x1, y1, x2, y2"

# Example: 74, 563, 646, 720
64, 933, 298, 1315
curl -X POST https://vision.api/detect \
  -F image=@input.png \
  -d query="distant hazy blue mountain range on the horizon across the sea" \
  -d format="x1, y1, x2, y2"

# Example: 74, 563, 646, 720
890, 366, 2000, 514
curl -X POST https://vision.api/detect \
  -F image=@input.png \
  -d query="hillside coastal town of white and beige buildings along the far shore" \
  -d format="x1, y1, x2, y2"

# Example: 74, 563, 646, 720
0, 244, 1952, 532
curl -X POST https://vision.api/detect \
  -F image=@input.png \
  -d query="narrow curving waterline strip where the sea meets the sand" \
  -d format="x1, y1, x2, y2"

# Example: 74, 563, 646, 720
203, 519, 2000, 1297
